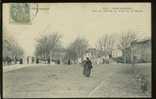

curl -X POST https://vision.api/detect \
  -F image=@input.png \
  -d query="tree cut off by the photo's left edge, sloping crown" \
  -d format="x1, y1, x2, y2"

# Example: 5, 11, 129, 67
2, 26, 24, 63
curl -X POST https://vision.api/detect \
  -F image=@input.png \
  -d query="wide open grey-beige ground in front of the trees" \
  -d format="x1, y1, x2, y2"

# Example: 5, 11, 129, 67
3, 64, 151, 98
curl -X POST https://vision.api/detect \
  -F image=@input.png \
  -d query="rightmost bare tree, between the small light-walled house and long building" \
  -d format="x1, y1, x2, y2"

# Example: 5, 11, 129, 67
119, 32, 137, 63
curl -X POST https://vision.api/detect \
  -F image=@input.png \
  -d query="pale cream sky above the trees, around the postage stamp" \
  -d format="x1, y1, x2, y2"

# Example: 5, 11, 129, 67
3, 3, 151, 55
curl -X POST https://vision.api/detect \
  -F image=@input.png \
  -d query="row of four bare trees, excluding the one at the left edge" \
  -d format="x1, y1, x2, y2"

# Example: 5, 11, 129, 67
35, 32, 136, 61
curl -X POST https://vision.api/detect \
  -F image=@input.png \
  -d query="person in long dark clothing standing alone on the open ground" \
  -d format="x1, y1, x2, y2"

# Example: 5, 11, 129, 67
83, 57, 93, 77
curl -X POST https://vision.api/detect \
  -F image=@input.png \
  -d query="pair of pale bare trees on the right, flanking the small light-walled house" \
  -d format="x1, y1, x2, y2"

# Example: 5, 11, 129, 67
97, 32, 137, 63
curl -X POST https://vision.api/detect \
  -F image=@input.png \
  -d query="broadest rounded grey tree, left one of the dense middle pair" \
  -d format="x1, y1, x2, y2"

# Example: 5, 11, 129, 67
35, 33, 61, 58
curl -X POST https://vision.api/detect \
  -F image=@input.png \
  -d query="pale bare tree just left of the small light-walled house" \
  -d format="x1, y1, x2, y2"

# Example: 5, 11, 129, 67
96, 34, 114, 55
